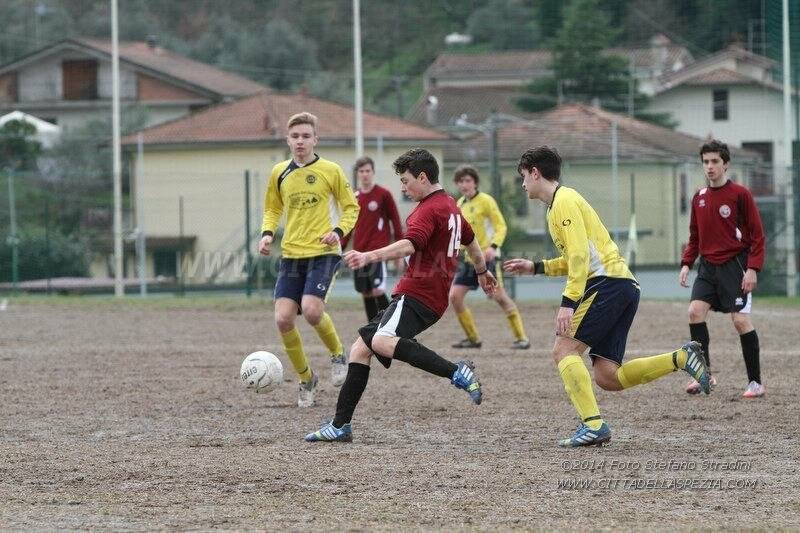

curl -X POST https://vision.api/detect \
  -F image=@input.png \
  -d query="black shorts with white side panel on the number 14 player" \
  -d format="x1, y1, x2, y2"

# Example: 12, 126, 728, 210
358, 294, 439, 368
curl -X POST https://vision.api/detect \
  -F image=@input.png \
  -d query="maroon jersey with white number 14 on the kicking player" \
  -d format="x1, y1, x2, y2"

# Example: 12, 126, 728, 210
392, 190, 475, 317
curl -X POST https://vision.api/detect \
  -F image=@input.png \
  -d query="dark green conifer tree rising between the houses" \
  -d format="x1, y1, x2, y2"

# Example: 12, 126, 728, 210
518, 0, 674, 127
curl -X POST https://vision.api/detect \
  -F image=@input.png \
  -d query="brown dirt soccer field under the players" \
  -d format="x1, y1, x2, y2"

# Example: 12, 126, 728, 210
0, 299, 800, 530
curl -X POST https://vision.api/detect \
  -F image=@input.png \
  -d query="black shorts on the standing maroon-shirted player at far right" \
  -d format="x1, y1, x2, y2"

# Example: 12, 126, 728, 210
692, 251, 753, 313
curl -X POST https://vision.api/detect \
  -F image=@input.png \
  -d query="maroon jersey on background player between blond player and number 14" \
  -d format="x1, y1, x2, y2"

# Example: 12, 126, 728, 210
342, 185, 403, 252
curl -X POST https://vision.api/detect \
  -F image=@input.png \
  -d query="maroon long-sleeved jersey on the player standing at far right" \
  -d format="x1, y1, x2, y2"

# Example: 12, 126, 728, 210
681, 180, 764, 270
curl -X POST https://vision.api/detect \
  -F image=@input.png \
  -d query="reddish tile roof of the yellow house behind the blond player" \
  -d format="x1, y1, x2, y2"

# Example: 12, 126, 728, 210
123, 92, 449, 145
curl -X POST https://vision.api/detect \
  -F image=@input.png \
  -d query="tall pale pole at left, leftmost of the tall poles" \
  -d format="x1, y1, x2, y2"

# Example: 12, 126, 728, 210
111, 0, 125, 298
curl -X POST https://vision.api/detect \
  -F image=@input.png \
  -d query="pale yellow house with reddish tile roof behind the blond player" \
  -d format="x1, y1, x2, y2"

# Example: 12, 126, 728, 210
115, 91, 449, 283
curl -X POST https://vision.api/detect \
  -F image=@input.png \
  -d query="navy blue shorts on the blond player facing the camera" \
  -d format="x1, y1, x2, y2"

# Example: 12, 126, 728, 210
275, 255, 342, 306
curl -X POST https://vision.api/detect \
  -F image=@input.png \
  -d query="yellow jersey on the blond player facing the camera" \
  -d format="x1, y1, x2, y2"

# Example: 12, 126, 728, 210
261, 156, 359, 259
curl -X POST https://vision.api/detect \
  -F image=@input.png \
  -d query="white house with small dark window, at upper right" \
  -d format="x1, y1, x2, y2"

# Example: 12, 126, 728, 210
648, 46, 797, 177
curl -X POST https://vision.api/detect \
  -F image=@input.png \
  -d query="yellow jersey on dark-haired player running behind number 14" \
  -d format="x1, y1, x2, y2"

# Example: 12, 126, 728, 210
543, 185, 636, 305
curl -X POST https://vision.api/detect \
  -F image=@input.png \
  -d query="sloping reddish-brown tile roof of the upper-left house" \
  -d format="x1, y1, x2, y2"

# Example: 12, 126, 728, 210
75, 39, 265, 96
